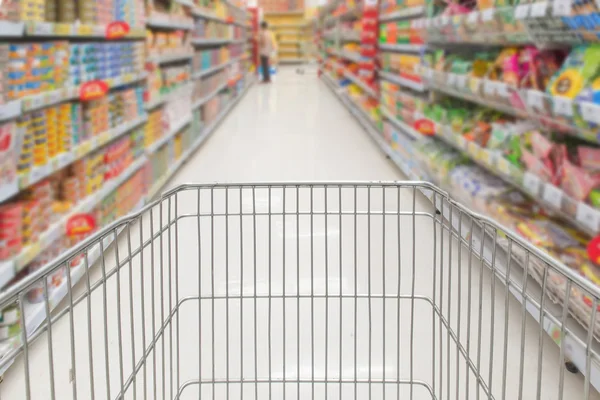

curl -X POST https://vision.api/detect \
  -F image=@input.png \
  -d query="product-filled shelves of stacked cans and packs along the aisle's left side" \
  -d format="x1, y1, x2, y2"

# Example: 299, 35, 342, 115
0, 0, 252, 375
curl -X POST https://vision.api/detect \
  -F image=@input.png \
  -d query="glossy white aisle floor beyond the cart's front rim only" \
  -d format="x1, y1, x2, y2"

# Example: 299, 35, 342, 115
165, 67, 402, 186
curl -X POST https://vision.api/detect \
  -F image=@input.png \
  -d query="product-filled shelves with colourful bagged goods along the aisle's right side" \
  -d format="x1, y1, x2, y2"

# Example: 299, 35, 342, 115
319, 0, 600, 396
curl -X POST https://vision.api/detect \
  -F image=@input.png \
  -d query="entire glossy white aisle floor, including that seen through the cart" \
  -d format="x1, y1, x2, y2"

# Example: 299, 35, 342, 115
0, 68, 597, 400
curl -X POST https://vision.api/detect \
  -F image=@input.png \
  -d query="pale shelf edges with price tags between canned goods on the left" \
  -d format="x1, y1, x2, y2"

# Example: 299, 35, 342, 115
0, 1, 254, 375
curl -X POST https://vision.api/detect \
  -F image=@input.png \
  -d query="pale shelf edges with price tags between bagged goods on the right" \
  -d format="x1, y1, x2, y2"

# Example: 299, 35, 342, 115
319, 2, 600, 391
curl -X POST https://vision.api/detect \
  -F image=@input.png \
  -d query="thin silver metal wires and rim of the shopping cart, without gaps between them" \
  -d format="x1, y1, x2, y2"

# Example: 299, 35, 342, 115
0, 181, 600, 399
